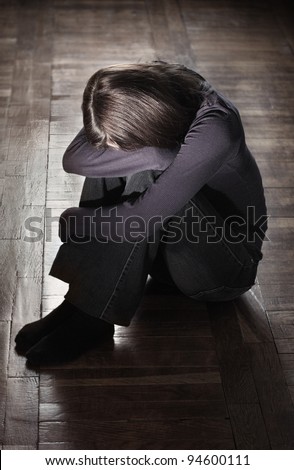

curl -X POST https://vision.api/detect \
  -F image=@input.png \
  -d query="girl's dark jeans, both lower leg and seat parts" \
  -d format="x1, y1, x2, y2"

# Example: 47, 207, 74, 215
50, 175, 262, 326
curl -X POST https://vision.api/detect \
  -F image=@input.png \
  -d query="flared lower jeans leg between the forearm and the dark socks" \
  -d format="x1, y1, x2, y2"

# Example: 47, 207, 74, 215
50, 240, 152, 326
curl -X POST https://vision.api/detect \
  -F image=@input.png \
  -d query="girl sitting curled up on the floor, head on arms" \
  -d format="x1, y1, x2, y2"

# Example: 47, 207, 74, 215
16, 62, 267, 365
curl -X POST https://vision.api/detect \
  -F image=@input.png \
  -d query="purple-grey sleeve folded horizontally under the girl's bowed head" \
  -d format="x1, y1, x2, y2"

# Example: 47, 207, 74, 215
62, 128, 179, 178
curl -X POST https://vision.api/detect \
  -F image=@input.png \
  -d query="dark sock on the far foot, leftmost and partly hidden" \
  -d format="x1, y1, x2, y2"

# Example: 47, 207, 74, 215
15, 300, 72, 354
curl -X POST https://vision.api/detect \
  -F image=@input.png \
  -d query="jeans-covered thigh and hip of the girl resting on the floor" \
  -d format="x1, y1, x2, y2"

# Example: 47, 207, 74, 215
151, 193, 262, 301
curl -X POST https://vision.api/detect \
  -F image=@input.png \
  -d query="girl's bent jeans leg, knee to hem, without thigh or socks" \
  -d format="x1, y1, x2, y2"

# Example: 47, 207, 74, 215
50, 172, 158, 326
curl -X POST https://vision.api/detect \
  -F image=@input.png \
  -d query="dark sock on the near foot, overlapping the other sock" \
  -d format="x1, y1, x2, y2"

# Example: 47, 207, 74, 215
26, 306, 114, 366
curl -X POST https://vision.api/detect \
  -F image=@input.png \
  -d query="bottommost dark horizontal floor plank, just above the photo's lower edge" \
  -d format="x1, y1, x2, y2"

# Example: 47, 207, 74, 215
39, 418, 234, 450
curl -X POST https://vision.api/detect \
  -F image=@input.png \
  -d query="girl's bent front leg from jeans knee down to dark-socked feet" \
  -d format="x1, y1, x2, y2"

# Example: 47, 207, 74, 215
16, 178, 158, 365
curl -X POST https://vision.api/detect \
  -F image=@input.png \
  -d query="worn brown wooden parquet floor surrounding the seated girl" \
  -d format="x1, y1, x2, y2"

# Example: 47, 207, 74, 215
0, 0, 294, 449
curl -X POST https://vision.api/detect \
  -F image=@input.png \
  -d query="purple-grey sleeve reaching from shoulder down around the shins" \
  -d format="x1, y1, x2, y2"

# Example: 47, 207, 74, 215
60, 108, 243, 241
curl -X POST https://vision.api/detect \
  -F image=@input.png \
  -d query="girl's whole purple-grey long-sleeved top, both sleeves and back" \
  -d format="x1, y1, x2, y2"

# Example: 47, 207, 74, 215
60, 92, 266, 253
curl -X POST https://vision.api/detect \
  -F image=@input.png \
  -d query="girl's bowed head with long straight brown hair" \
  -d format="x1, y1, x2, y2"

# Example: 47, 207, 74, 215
82, 62, 211, 150
